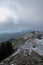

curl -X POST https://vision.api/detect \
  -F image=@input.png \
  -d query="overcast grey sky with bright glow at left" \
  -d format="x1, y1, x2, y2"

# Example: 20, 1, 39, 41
0, 0, 43, 32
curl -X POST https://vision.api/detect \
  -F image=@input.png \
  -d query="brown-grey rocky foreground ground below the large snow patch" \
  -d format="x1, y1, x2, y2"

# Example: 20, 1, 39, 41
0, 50, 43, 65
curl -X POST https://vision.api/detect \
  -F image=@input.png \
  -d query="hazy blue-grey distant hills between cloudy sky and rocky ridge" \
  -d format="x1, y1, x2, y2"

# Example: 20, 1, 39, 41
0, 30, 34, 42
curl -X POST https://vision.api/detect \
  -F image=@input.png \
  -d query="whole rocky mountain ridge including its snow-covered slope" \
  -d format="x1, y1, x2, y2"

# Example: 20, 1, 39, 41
0, 32, 43, 65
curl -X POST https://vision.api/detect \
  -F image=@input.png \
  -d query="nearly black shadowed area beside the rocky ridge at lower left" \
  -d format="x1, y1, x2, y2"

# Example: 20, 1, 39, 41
0, 41, 13, 61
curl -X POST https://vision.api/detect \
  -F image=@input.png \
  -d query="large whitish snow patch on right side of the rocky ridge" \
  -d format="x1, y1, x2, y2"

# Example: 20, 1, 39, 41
21, 39, 43, 55
